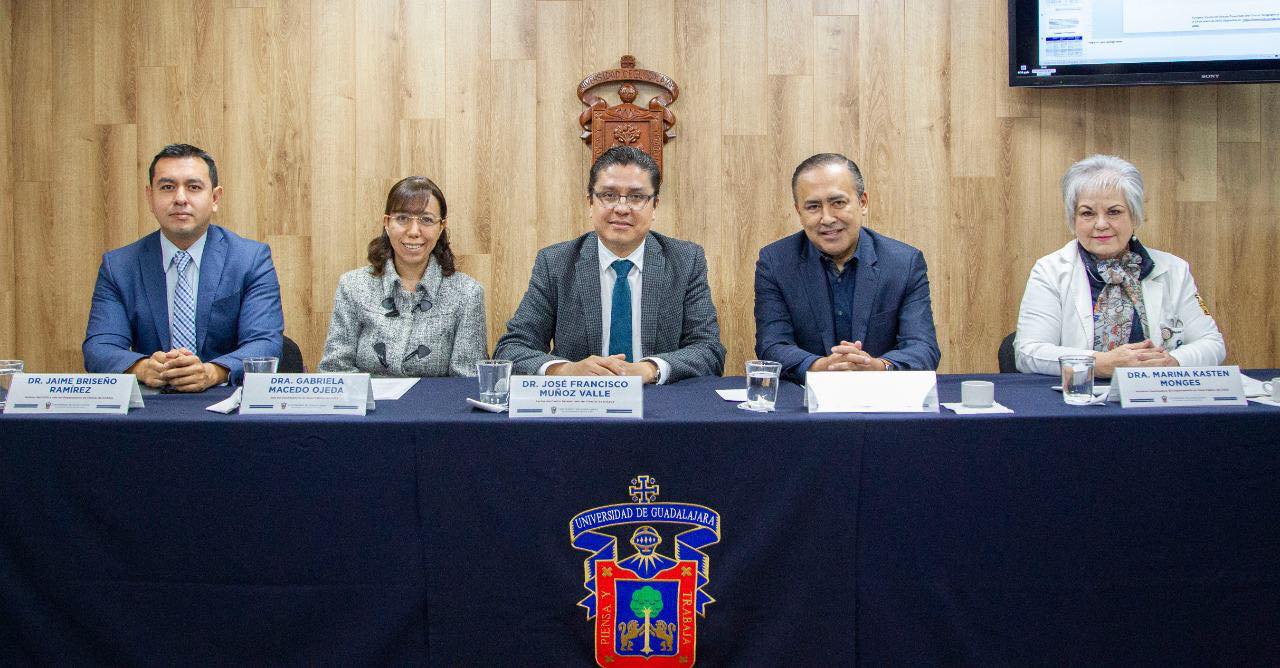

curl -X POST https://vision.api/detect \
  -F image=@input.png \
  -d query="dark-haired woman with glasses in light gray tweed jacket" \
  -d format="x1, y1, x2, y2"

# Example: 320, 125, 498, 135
319, 177, 488, 376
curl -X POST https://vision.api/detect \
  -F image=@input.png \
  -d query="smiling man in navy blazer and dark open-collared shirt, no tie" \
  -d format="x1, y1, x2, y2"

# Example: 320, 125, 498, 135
755, 154, 941, 383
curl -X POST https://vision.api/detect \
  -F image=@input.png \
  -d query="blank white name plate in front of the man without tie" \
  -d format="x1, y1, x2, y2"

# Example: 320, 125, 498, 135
805, 371, 938, 413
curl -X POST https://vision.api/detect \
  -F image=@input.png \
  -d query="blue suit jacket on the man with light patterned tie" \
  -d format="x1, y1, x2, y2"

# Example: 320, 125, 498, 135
82, 225, 284, 383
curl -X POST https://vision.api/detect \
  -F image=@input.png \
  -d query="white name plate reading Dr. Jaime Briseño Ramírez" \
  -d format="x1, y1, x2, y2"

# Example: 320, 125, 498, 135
4, 374, 142, 415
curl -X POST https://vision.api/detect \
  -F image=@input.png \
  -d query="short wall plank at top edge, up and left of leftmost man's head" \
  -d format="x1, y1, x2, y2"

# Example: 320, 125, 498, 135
93, 0, 138, 125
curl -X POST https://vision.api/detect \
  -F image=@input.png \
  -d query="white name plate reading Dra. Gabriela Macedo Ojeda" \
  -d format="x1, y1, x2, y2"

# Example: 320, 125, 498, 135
241, 374, 374, 415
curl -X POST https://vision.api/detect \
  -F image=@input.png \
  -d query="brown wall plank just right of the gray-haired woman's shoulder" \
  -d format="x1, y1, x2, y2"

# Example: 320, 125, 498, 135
1208, 142, 1280, 367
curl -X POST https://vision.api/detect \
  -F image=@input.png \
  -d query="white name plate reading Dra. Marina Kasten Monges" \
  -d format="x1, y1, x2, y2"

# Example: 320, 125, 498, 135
1111, 366, 1247, 408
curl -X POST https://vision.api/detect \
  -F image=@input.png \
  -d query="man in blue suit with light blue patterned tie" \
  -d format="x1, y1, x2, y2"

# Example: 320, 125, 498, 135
83, 143, 284, 392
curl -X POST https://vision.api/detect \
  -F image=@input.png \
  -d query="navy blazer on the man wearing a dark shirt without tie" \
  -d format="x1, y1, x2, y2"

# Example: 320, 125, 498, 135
755, 228, 941, 383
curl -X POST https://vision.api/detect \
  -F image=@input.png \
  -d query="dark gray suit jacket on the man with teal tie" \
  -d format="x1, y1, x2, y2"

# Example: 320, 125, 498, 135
494, 232, 724, 383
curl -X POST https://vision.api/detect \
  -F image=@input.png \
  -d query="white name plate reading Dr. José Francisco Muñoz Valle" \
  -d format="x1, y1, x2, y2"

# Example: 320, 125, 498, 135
509, 376, 644, 418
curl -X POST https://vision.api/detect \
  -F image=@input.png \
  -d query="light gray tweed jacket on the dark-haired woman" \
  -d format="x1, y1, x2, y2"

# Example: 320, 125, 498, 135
319, 257, 488, 376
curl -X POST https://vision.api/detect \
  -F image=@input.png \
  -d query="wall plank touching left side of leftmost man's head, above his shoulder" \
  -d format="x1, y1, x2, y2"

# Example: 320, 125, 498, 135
92, 124, 142, 250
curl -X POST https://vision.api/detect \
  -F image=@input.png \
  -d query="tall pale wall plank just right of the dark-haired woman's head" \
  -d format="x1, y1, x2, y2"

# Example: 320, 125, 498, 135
436, 0, 494, 255
